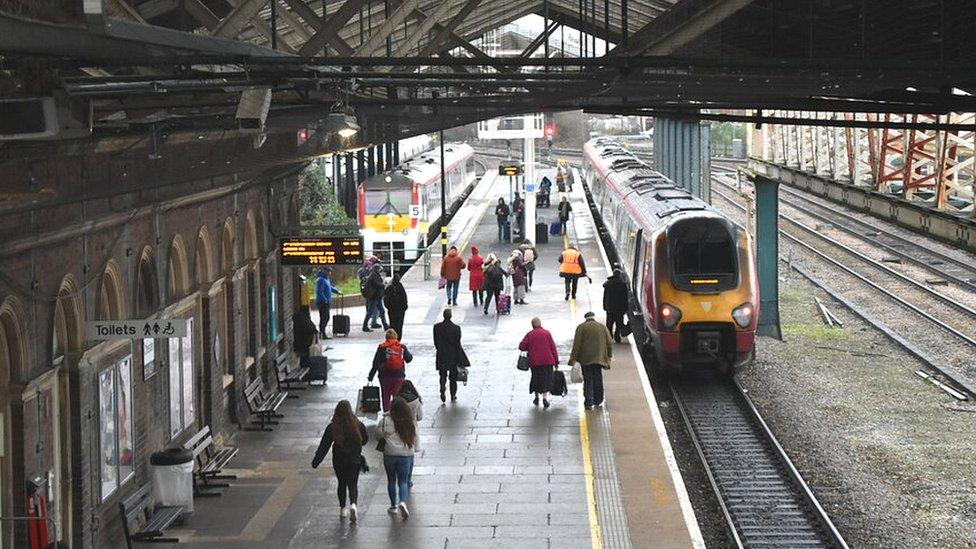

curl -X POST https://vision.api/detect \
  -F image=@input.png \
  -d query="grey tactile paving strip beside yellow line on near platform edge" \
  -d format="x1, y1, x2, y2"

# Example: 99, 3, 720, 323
586, 408, 633, 549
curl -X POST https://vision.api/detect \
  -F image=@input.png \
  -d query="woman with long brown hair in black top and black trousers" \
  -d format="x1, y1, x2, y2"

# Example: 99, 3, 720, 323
312, 400, 369, 522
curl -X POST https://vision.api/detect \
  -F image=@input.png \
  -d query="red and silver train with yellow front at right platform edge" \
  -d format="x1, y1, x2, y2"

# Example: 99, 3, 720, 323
583, 138, 759, 371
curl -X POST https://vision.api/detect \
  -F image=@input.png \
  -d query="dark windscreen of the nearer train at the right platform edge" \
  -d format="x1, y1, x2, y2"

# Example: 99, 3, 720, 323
667, 218, 739, 293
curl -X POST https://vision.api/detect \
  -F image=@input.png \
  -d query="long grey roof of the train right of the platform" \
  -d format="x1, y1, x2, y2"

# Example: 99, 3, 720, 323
583, 137, 725, 228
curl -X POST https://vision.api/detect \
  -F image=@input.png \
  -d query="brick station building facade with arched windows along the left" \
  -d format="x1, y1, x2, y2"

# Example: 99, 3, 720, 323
0, 131, 312, 549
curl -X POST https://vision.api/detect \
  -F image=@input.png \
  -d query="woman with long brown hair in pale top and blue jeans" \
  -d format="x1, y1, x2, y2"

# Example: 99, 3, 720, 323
376, 397, 420, 520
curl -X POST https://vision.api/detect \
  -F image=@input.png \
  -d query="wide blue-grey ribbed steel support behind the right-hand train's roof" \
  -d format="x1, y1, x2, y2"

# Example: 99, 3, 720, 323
654, 117, 711, 202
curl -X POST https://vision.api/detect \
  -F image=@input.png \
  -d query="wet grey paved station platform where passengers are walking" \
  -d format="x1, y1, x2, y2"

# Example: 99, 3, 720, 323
160, 169, 704, 549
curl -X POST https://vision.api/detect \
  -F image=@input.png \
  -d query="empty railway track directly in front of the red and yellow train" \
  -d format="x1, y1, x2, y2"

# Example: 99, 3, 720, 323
671, 376, 847, 548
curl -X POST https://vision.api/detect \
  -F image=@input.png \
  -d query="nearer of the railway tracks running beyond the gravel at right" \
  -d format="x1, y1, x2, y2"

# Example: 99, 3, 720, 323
712, 172, 976, 397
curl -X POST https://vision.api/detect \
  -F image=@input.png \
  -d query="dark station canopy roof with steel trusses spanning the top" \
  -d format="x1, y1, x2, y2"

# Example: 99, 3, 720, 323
0, 0, 976, 146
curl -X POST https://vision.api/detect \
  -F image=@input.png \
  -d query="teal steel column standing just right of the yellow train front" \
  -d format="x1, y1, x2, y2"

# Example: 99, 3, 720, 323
753, 175, 783, 339
